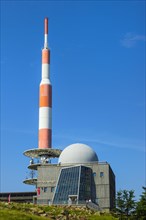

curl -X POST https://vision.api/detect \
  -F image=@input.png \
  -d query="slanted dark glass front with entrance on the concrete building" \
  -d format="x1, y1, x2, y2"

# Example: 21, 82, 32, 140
53, 166, 92, 204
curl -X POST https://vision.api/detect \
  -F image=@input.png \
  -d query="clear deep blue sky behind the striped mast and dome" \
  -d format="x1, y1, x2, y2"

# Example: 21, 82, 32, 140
0, 0, 146, 199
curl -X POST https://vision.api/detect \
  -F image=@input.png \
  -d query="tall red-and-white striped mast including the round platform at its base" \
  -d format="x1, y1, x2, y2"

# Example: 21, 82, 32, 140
24, 18, 61, 170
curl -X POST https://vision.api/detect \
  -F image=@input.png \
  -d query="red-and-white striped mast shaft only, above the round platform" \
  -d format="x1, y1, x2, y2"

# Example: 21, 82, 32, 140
39, 18, 52, 148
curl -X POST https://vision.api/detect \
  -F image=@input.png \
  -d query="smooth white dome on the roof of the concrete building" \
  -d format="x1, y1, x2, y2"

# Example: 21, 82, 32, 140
58, 143, 98, 164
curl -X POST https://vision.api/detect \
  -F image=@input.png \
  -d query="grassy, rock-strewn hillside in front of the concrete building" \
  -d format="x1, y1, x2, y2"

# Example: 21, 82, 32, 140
0, 202, 117, 220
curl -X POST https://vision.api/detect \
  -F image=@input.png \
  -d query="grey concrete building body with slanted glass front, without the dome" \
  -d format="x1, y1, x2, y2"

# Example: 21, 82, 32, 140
37, 162, 115, 210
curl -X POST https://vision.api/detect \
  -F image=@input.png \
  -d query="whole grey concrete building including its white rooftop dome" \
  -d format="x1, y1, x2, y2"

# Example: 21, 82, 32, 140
25, 143, 115, 210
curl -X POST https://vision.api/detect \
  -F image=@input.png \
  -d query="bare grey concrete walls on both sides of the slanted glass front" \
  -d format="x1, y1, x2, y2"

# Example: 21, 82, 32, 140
37, 163, 115, 209
